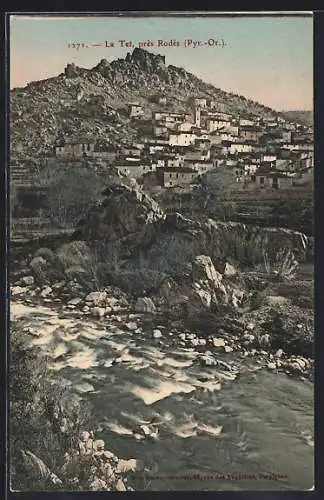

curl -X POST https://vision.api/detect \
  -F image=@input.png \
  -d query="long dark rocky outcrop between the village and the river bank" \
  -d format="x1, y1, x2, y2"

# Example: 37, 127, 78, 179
75, 192, 310, 276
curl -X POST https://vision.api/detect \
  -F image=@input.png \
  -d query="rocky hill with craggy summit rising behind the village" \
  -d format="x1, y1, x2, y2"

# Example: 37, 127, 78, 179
10, 48, 286, 157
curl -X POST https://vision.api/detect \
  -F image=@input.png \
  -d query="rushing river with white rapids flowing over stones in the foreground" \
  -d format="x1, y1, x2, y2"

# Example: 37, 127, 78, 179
11, 302, 314, 490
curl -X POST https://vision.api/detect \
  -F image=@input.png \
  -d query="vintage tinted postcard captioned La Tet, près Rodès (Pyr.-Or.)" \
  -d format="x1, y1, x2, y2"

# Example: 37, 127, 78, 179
8, 12, 314, 492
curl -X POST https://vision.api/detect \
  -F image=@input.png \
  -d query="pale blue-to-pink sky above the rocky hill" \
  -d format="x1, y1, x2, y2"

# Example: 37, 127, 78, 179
10, 13, 313, 111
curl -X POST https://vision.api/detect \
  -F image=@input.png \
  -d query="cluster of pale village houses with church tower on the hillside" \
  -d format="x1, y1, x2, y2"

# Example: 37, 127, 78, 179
11, 73, 314, 190
